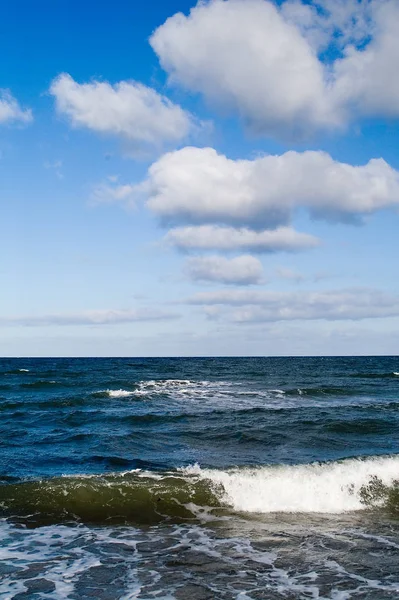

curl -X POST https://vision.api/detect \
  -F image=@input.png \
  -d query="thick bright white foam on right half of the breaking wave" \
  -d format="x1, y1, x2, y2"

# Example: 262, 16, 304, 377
183, 456, 399, 514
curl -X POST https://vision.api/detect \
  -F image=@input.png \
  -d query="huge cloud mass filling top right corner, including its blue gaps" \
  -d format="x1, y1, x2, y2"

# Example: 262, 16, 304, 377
150, 0, 399, 137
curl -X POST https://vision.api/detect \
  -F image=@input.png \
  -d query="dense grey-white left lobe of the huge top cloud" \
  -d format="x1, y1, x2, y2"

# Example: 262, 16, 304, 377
150, 0, 342, 133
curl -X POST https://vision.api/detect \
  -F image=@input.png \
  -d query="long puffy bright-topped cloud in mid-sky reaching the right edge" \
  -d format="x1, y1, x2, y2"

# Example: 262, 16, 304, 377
145, 147, 399, 229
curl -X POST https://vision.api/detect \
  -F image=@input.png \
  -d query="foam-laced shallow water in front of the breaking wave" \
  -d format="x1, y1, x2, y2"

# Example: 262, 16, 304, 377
0, 521, 399, 600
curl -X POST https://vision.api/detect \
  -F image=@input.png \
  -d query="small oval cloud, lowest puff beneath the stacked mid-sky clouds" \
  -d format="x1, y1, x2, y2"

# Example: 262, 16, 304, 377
186, 255, 263, 285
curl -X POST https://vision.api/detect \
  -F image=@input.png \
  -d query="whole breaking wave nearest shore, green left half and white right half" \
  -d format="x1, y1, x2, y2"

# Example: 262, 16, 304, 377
0, 456, 399, 524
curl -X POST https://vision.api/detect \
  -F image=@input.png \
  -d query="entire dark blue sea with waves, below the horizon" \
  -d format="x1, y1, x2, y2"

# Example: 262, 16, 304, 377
0, 357, 399, 600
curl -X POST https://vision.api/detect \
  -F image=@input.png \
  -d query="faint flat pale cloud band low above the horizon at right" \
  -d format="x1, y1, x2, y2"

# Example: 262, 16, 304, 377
187, 289, 399, 323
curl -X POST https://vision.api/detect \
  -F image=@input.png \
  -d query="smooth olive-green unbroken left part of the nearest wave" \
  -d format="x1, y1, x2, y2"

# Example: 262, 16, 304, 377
0, 470, 220, 525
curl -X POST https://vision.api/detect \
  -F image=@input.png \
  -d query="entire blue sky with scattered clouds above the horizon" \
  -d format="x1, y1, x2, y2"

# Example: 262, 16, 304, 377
0, 0, 399, 356
